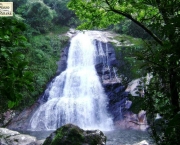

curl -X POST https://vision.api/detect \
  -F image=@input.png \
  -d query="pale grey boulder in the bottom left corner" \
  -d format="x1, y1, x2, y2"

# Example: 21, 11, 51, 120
0, 128, 38, 145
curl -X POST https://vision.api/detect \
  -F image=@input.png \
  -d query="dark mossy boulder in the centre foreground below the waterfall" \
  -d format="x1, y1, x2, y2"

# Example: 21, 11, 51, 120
43, 124, 106, 145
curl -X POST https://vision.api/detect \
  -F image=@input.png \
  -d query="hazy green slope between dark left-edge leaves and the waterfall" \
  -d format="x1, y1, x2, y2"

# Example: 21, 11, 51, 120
22, 31, 68, 107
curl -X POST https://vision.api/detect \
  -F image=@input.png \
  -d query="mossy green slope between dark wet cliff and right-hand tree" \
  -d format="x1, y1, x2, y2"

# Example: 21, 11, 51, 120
114, 35, 146, 85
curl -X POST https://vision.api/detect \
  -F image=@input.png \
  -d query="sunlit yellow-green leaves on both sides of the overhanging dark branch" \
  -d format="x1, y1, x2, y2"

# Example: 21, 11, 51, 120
68, 0, 162, 28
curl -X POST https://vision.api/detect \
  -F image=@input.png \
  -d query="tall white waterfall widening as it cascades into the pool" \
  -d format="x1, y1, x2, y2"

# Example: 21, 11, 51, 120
29, 31, 113, 131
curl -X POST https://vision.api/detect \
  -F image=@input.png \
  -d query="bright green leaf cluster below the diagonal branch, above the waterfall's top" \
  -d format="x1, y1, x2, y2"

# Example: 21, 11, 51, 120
68, 0, 122, 29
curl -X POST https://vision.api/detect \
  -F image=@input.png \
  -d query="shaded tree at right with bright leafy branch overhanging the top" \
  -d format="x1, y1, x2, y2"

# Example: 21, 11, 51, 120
69, 0, 180, 145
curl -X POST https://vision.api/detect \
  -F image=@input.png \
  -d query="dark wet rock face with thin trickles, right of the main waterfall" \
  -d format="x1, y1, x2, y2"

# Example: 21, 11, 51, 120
95, 40, 129, 121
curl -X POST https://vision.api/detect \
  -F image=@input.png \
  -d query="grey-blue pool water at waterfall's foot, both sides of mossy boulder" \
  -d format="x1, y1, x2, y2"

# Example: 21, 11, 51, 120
21, 129, 155, 145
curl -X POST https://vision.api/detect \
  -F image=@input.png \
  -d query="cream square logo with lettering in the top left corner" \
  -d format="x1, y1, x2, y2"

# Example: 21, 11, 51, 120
0, 2, 13, 17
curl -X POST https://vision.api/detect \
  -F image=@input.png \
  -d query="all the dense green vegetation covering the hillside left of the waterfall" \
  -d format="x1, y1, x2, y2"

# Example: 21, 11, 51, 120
0, 0, 74, 122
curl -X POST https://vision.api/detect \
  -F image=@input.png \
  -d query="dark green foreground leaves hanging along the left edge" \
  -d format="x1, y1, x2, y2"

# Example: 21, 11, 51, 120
0, 17, 33, 110
